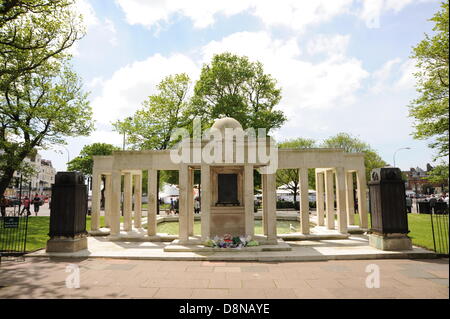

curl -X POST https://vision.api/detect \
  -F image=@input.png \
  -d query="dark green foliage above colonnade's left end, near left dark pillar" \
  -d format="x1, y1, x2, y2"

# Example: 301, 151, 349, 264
68, 143, 120, 175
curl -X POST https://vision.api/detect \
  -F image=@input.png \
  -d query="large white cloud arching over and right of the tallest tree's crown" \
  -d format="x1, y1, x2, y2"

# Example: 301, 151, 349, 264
202, 32, 368, 121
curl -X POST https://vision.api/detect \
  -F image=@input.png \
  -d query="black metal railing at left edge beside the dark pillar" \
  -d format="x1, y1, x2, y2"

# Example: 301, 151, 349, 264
0, 213, 28, 261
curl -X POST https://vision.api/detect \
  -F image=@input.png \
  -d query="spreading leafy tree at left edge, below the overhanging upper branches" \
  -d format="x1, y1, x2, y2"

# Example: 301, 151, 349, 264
0, 62, 93, 194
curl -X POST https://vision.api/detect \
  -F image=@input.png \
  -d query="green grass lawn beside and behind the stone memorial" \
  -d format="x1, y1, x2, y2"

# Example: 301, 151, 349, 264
0, 214, 440, 251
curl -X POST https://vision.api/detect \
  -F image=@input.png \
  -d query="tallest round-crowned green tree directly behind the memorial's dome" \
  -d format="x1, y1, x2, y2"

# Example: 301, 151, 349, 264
192, 53, 286, 133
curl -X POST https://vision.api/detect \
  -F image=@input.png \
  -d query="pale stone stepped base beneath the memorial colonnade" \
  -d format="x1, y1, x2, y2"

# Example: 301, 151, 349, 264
28, 235, 435, 262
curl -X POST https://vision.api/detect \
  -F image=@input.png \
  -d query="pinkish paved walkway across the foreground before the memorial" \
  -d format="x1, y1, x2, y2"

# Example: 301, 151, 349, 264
0, 258, 449, 299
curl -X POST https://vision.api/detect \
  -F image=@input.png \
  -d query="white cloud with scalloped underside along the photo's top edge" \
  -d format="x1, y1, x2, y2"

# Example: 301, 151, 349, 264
116, 0, 352, 30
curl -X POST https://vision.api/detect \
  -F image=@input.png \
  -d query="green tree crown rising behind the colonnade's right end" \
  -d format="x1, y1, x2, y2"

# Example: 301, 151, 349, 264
322, 133, 387, 181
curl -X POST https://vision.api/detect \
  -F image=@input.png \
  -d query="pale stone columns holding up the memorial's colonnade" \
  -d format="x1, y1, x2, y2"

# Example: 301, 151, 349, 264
91, 164, 368, 242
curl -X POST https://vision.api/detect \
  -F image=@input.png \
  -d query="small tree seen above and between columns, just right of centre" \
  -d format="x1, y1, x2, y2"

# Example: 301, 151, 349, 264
277, 138, 316, 203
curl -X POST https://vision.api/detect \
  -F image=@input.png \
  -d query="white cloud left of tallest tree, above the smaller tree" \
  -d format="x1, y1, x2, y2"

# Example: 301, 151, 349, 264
92, 54, 199, 124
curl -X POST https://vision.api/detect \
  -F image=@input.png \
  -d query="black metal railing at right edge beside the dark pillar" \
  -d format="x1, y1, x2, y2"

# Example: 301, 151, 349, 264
430, 206, 449, 255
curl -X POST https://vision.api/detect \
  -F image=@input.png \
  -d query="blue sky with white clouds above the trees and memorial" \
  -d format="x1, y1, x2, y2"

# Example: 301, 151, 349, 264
41, 0, 440, 170
